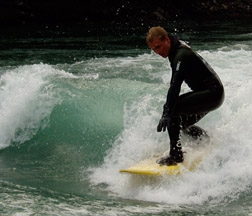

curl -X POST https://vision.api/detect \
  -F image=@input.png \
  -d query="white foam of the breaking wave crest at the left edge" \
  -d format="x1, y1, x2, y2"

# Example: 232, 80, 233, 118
0, 64, 66, 148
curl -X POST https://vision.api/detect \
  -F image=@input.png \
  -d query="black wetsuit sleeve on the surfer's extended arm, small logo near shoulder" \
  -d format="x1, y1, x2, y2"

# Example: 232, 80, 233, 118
163, 60, 184, 116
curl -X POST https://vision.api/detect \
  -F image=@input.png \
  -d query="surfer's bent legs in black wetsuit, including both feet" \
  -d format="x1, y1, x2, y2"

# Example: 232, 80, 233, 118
157, 90, 220, 165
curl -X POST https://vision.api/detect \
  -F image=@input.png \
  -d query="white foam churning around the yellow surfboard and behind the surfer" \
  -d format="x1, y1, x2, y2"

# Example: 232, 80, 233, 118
91, 45, 252, 204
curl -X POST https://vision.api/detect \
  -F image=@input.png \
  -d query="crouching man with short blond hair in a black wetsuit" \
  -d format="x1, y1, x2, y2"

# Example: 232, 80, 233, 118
146, 26, 224, 166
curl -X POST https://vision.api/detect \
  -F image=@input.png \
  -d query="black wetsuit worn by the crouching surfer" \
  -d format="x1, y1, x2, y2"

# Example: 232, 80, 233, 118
163, 36, 224, 148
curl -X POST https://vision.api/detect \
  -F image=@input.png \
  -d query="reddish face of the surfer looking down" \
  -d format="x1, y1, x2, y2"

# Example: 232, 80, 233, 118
148, 36, 171, 58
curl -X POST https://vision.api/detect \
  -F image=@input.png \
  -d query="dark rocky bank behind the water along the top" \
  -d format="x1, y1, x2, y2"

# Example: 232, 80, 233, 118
0, 0, 252, 24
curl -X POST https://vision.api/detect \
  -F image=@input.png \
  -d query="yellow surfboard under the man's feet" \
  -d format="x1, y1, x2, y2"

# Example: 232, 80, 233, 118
120, 155, 202, 176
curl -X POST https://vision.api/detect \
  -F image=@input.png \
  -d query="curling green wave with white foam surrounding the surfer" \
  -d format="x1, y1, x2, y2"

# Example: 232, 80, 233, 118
0, 45, 252, 205
